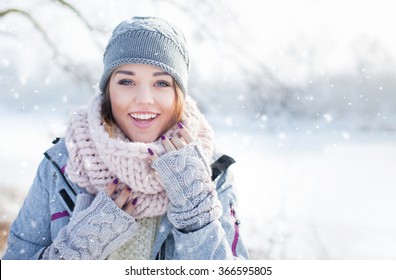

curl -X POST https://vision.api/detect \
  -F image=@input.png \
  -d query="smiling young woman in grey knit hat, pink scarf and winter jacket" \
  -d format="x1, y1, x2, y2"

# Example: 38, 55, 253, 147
3, 17, 248, 259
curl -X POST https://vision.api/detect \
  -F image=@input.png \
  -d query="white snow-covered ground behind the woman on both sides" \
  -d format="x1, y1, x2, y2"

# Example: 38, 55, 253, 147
0, 109, 396, 259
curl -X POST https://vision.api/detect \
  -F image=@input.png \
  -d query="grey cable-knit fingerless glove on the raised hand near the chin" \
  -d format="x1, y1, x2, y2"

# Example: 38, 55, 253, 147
152, 143, 221, 232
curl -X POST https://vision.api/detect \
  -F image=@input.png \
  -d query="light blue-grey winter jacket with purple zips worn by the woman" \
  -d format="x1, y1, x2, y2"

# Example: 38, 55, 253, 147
2, 139, 249, 260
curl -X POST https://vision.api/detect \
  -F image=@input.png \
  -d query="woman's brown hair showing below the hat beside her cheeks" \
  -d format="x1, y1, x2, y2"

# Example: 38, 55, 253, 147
101, 79, 184, 137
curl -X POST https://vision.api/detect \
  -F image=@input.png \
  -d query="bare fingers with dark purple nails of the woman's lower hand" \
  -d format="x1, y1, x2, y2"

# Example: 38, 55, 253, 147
105, 178, 137, 215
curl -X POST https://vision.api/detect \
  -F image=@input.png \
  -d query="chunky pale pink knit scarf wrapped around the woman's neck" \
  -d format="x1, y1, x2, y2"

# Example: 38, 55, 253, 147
66, 94, 214, 218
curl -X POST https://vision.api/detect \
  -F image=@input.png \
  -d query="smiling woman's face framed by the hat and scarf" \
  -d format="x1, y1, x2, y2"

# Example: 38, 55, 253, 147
109, 64, 176, 143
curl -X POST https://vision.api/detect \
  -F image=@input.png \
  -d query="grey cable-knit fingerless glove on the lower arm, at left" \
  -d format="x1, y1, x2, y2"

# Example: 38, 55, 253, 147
43, 192, 138, 260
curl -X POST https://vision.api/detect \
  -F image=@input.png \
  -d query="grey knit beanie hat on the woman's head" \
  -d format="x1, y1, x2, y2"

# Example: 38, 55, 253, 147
99, 17, 189, 94
